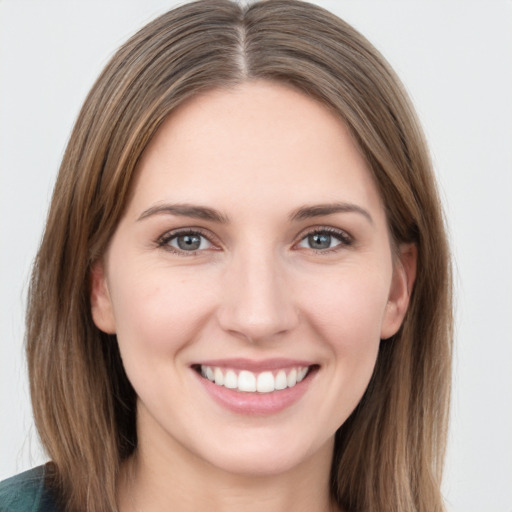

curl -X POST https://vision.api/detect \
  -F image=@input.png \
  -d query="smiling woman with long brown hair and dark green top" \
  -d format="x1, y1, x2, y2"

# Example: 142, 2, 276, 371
0, 0, 451, 512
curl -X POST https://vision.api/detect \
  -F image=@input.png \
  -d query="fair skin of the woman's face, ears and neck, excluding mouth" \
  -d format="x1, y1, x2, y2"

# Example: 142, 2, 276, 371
91, 81, 415, 512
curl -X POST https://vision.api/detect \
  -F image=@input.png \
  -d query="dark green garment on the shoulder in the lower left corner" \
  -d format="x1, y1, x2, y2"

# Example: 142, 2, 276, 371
0, 466, 58, 512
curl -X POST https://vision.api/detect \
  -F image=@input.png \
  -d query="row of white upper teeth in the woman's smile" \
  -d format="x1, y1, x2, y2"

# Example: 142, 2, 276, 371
201, 365, 309, 393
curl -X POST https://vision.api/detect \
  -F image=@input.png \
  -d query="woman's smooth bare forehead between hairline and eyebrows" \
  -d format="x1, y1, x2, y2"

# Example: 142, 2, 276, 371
128, 81, 380, 220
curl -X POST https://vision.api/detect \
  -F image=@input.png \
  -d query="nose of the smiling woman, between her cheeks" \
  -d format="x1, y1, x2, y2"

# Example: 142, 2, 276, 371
218, 248, 299, 342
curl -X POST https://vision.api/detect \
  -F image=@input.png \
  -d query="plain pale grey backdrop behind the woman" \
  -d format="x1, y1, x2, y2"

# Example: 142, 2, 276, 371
0, 0, 512, 512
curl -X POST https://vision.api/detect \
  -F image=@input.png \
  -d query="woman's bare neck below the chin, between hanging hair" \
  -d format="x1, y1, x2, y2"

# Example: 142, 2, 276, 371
119, 424, 338, 512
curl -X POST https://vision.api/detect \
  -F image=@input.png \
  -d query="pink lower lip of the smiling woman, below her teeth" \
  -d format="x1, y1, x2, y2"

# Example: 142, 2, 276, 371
194, 371, 316, 416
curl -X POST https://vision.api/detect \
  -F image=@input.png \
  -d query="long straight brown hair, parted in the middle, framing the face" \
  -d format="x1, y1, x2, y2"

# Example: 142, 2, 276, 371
27, 0, 452, 512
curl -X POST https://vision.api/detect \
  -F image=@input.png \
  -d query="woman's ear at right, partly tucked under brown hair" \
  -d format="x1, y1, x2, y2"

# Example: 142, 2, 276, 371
380, 244, 418, 340
